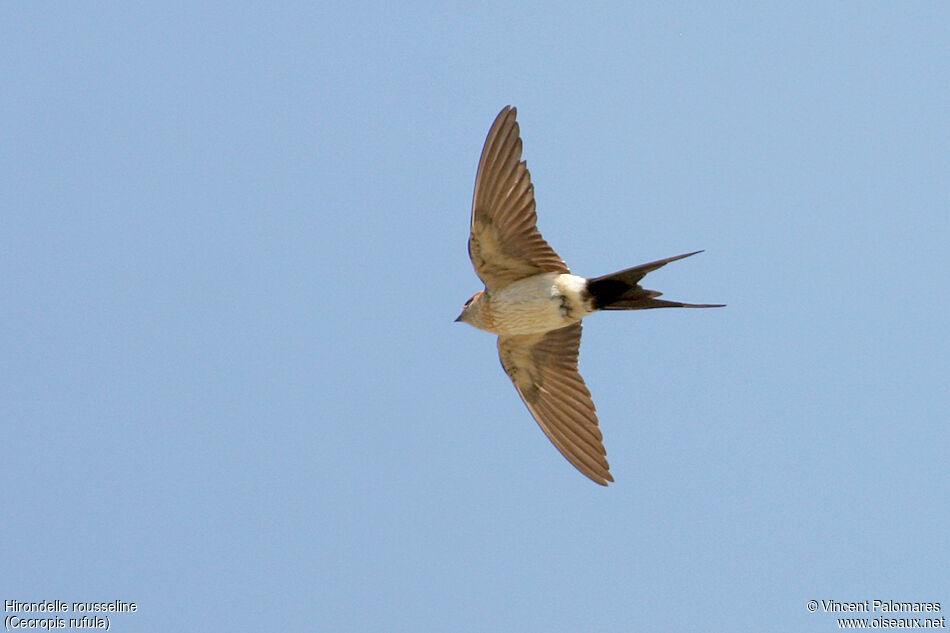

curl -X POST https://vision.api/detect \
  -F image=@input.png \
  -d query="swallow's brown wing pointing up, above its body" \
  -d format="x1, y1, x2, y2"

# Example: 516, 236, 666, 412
468, 106, 571, 290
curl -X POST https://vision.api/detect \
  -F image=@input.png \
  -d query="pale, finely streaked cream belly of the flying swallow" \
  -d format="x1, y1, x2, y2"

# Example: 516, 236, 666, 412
491, 273, 587, 334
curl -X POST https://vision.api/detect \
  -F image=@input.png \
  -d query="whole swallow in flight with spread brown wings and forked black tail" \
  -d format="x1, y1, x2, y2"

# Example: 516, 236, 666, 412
456, 106, 722, 486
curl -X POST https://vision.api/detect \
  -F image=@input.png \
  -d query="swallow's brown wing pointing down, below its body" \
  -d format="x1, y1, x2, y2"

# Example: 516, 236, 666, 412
498, 322, 614, 486
